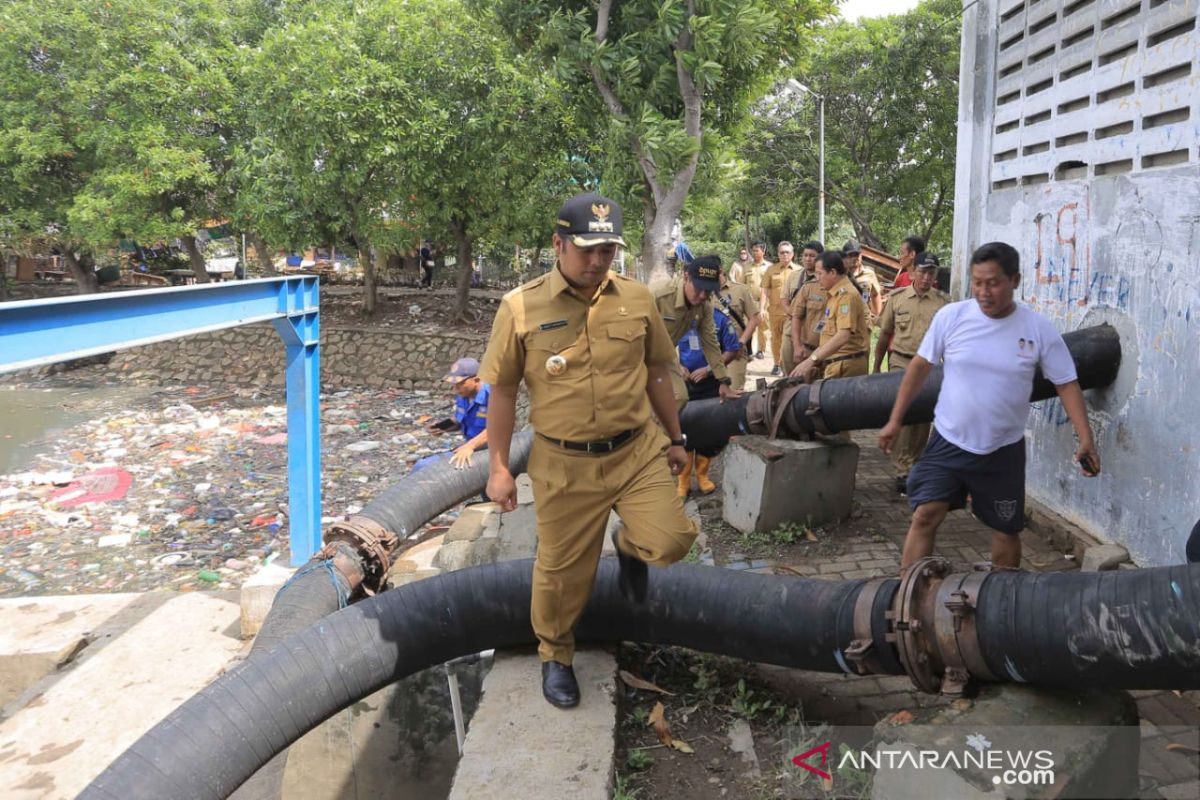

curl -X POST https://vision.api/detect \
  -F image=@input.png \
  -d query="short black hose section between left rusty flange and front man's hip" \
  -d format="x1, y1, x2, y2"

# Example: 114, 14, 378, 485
358, 431, 533, 540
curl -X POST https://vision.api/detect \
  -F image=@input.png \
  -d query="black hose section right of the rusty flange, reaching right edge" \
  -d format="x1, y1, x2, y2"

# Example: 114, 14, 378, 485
976, 565, 1200, 690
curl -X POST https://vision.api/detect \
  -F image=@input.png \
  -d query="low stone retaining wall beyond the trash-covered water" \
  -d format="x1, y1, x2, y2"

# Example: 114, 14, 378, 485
108, 325, 487, 391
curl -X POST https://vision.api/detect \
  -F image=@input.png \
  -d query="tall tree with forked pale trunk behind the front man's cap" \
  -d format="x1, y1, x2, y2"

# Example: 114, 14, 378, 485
475, 0, 833, 276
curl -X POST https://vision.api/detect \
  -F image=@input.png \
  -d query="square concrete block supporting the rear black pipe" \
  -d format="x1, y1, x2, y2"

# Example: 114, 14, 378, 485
722, 437, 858, 533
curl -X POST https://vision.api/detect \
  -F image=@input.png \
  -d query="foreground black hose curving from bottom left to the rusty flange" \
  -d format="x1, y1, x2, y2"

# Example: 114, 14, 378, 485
79, 559, 863, 800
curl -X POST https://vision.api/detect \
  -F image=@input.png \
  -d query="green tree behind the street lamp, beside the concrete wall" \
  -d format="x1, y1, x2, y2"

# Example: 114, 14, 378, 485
742, 0, 961, 251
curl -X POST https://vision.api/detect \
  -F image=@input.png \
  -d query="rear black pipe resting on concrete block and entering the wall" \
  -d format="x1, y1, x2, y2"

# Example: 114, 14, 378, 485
680, 325, 1121, 450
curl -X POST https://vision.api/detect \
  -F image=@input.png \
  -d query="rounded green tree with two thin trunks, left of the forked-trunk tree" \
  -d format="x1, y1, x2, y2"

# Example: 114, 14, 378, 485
239, 0, 568, 319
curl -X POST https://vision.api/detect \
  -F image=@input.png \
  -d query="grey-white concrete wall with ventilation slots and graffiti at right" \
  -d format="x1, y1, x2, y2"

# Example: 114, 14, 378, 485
954, 0, 1200, 564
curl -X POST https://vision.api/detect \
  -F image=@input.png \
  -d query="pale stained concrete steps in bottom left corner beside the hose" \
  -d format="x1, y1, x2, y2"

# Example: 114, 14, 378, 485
0, 593, 247, 800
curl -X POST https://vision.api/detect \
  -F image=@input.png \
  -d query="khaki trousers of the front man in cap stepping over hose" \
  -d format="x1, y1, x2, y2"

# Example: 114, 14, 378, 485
528, 423, 696, 664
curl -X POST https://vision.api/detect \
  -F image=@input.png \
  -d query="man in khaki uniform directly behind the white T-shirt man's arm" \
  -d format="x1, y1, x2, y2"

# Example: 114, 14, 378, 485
875, 253, 950, 494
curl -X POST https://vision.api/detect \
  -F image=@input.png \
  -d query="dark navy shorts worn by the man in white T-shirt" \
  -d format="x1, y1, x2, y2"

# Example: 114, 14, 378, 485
908, 427, 1025, 535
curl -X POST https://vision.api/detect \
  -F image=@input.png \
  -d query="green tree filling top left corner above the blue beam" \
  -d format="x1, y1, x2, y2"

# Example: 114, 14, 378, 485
0, 0, 241, 290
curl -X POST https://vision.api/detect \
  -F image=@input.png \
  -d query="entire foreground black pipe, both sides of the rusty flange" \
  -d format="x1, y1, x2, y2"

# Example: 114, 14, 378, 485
80, 559, 1200, 800
